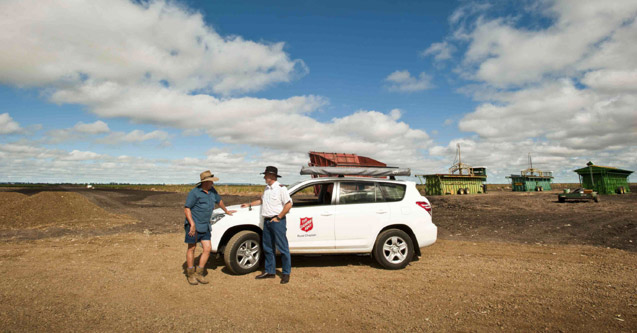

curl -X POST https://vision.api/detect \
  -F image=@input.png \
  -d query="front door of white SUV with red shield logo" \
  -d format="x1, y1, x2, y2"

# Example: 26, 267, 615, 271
287, 182, 334, 249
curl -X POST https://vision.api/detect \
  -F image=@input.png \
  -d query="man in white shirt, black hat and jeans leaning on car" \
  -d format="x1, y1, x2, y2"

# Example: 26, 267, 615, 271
241, 166, 292, 284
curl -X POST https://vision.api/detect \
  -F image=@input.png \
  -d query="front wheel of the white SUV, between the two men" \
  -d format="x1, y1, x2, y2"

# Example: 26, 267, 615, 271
223, 230, 262, 275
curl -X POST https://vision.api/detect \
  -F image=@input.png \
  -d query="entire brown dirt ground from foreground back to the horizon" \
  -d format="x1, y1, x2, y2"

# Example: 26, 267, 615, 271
0, 188, 637, 332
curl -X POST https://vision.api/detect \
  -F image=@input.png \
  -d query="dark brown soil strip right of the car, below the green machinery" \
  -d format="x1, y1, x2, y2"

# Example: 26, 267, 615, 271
429, 191, 637, 252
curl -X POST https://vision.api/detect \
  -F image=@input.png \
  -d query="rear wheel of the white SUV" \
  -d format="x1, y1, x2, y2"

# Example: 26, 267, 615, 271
372, 229, 414, 269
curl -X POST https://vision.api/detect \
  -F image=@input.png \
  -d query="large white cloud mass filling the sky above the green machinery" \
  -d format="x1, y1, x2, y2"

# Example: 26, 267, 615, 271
428, 0, 637, 175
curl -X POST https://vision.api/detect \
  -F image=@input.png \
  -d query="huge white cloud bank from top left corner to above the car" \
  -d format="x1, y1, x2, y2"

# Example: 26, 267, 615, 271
0, 0, 431, 182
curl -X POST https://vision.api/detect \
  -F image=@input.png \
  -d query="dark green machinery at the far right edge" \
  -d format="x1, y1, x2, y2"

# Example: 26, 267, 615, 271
575, 162, 633, 194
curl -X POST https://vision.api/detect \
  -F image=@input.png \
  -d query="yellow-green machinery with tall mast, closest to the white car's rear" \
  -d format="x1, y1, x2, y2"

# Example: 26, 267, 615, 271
416, 145, 487, 195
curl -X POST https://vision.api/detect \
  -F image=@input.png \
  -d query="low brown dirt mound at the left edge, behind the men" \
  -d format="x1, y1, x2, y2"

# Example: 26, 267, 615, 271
0, 192, 135, 229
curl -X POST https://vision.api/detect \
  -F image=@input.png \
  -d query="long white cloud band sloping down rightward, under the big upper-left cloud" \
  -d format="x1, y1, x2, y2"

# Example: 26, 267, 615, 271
47, 83, 428, 157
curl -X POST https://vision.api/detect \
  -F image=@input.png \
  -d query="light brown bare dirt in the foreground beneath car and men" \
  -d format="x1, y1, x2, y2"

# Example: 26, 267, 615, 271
0, 233, 637, 332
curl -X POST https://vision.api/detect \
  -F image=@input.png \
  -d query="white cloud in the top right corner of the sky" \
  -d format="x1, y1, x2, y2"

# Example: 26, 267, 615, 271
458, 0, 637, 87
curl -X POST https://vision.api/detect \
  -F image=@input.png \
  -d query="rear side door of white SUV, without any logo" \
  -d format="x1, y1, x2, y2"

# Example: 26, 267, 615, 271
334, 181, 390, 251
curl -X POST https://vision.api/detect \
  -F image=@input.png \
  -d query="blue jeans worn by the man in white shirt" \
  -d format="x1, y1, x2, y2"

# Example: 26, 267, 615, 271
263, 217, 292, 274
